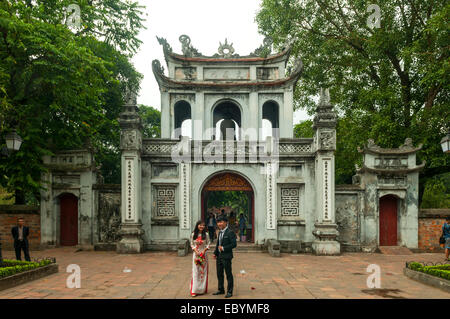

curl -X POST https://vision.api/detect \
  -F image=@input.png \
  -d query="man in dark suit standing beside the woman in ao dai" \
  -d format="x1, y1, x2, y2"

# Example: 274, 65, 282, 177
213, 216, 236, 298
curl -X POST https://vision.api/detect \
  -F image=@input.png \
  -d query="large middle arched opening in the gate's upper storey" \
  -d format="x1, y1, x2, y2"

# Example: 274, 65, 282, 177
213, 101, 241, 140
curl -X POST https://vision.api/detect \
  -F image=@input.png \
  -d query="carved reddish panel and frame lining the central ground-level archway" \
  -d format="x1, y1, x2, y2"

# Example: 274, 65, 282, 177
201, 172, 255, 242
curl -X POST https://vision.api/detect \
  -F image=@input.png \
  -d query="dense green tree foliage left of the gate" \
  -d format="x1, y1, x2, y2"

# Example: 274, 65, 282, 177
0, 0, 143, 203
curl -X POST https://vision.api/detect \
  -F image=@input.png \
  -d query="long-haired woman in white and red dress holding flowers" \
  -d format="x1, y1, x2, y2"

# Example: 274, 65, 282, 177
190, 221, 211, 297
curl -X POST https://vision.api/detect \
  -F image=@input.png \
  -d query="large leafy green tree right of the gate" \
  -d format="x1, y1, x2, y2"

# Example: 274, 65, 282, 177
256, 0, 450, 183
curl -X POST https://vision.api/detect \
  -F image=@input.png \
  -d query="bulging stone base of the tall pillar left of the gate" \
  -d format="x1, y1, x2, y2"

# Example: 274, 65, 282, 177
116, 224, 144, 254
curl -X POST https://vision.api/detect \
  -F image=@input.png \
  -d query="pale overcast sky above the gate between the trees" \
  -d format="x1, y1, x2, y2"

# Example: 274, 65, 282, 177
133, 0, 309, 124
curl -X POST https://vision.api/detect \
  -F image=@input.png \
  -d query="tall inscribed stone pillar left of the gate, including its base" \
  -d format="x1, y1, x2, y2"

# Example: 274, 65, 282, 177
117, 93, 144, 254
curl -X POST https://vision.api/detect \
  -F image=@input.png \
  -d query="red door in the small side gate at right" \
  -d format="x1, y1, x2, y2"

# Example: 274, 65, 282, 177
380, 195, 397, 246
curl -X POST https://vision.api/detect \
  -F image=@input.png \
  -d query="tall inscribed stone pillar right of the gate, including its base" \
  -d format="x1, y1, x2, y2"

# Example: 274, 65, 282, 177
312, 89, 341, 255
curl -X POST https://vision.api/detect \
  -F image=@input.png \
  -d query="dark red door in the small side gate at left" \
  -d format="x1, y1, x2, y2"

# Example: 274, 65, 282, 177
60, 194, 78, 246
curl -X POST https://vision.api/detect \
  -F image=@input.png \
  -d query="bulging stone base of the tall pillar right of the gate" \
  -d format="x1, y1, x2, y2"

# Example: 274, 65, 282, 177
312, 223, 341, 256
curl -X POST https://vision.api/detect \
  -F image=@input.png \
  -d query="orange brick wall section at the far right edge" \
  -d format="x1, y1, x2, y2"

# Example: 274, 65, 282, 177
419, 209, 450, 252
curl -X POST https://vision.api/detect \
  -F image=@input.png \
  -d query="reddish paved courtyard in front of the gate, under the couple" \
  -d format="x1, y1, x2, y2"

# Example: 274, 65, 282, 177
0, 247, 450, 299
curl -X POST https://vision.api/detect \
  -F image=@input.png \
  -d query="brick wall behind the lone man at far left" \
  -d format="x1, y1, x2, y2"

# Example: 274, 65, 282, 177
0, 205, 41, 250
